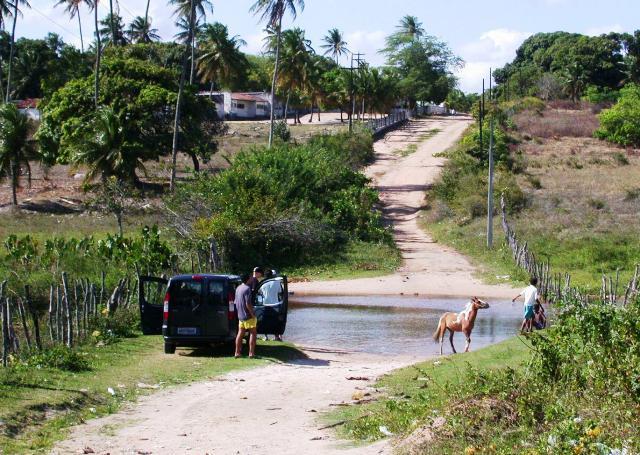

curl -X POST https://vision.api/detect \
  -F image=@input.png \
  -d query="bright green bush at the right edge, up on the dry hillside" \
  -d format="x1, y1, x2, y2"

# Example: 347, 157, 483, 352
595, 85, 640, 147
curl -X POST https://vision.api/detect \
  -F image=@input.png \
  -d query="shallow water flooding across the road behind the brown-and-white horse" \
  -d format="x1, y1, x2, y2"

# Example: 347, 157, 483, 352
286, 296, 522, 356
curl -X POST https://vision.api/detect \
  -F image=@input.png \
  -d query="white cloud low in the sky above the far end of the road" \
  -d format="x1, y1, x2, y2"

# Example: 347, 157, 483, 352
456, 28, 531, 92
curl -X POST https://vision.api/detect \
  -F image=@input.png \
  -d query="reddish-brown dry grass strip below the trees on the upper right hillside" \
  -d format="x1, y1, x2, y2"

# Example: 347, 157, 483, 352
513, 109, 600, 139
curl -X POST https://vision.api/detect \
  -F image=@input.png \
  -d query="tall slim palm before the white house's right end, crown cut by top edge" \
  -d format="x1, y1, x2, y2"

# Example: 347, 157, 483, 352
250, 0, 304, 147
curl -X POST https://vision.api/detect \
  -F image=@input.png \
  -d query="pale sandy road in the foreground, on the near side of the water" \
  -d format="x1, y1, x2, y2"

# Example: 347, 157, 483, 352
52, 348, 418, 455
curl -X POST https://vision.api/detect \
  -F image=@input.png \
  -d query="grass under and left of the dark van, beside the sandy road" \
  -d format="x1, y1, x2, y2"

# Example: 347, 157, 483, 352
0, 336, 303, 453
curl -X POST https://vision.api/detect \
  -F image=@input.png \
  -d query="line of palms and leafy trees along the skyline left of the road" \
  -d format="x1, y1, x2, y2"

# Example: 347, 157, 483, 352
0, 0, 461, 202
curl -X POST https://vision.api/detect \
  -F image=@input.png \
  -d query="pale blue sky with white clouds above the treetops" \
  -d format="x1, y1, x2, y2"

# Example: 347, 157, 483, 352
21, 0, 640, 92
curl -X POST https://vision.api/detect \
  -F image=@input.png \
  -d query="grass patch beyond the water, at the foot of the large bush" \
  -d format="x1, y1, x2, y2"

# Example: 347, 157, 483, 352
287, 241, 402, 281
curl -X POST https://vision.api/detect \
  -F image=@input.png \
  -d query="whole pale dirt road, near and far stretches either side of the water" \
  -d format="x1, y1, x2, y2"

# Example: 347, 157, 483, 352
53, 118, 513, 455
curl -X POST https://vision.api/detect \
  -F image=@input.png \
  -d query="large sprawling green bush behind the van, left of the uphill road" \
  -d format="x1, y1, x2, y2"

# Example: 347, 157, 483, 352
167, 133, 391, 270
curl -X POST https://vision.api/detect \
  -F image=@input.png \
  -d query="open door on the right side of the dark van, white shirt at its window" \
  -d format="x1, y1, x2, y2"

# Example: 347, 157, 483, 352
253, 276, 289, 335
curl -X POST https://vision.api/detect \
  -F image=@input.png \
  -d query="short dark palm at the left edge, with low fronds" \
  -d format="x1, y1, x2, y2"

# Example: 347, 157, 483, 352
0, 103, 35, 207
